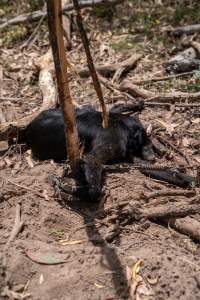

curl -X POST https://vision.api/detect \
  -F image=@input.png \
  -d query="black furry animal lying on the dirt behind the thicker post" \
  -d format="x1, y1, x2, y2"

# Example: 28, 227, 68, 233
19, 105, 154, 199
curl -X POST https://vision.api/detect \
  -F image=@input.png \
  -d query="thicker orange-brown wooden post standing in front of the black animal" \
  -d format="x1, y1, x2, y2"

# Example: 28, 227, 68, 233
46, 0, 79, 172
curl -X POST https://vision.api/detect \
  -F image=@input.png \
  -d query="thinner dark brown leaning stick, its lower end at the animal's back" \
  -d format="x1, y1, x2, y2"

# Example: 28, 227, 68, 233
73, 0, 108, 128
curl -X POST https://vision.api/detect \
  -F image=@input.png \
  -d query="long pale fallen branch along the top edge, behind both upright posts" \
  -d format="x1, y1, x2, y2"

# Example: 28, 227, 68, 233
0, 0, 123, 29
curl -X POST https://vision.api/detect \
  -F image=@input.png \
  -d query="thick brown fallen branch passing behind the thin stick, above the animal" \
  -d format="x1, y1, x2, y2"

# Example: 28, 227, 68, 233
77, 55, 142, 77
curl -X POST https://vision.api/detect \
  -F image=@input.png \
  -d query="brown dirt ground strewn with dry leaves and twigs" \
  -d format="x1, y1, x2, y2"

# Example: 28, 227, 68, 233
0, 0, 200, 300
